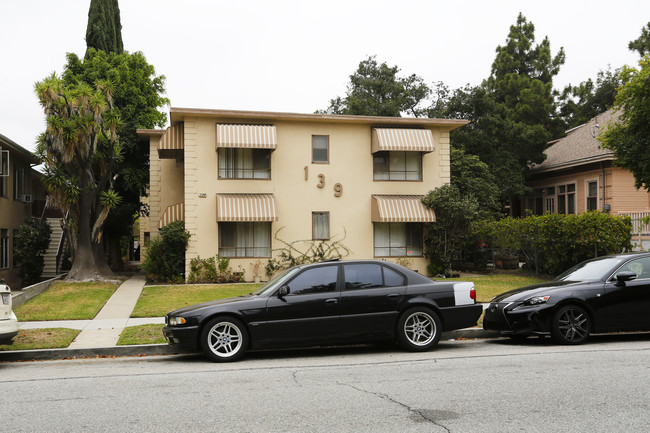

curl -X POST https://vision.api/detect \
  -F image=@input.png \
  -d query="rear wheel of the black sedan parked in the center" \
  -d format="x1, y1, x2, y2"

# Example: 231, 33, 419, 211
397, 307, 442, 352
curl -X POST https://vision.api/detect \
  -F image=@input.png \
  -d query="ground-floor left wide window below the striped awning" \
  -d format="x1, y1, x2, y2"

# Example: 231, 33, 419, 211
219, 222, 271, 257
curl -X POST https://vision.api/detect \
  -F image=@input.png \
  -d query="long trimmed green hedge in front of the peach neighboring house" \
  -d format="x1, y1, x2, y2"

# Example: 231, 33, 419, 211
473, 212, 632, 274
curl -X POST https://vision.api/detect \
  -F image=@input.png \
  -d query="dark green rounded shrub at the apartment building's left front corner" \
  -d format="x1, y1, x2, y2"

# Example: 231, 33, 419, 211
140, 221, 190, 282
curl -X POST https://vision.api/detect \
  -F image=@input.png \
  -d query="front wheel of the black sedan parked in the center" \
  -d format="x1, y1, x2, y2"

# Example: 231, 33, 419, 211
200, 317, 248, 362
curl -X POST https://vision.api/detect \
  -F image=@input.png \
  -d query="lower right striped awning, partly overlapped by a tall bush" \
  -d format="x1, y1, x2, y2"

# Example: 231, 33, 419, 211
372, 195, 436, 223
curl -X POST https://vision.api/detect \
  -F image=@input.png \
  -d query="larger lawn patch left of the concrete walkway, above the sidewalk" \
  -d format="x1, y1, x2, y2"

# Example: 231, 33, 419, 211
14, 282, 118, 322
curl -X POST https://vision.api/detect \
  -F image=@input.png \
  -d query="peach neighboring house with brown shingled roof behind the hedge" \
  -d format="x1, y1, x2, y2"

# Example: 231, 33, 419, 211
520, 110, 650, 243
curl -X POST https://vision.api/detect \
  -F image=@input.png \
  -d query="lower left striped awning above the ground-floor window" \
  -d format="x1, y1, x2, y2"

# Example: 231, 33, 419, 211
217, 194, 278, 222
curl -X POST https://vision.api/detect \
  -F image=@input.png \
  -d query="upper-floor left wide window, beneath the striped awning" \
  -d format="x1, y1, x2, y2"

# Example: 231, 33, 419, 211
219, 148, 271, 179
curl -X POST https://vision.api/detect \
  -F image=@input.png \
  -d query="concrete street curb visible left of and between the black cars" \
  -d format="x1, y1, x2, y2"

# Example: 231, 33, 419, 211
0, 328, 499, 363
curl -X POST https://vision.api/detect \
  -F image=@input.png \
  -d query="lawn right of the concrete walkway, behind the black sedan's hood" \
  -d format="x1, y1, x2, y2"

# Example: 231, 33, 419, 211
131, 284, 261, 317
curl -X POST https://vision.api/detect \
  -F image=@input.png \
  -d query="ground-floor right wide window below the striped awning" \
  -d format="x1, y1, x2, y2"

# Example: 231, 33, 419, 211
374, 223, 422, 257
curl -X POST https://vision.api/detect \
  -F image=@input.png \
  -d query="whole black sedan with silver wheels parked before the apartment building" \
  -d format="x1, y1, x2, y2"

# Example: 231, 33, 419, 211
163, 260, 483, 361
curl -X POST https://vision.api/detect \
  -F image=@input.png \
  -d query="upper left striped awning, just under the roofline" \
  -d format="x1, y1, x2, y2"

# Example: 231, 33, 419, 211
217, 123, 278, 150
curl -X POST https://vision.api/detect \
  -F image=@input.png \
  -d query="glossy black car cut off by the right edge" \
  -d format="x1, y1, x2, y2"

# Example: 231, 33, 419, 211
483, 253, 650, 344
